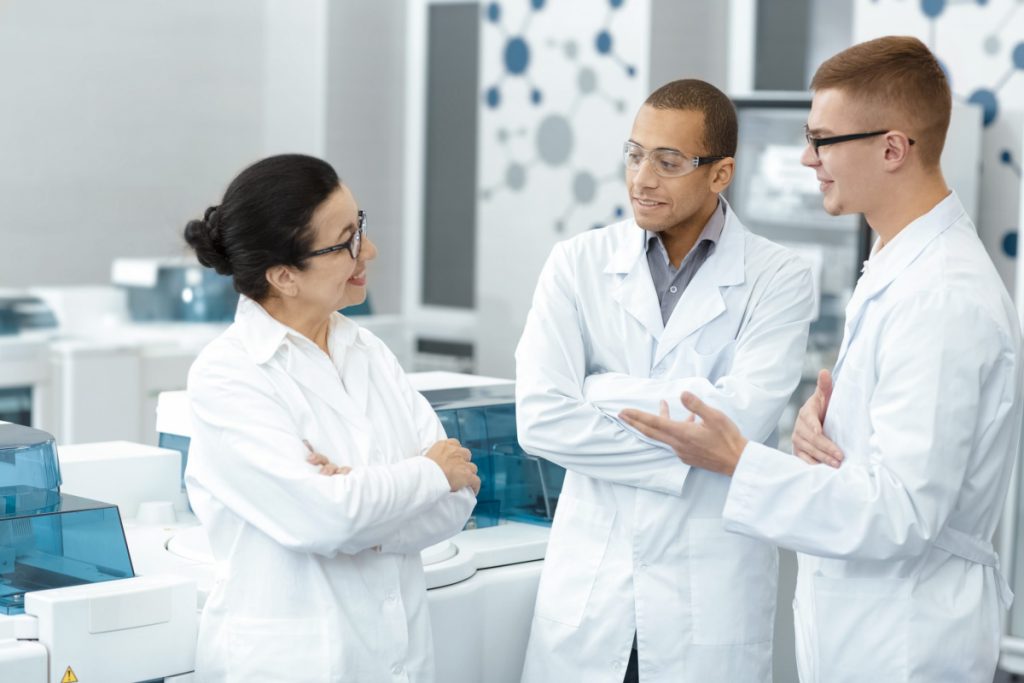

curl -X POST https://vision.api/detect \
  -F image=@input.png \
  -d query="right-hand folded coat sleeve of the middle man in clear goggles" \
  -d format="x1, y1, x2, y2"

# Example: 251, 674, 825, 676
584, 261, 814, 442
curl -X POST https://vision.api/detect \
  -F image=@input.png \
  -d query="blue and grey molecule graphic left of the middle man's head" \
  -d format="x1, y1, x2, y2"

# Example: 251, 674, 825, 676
480, 0, 636, 232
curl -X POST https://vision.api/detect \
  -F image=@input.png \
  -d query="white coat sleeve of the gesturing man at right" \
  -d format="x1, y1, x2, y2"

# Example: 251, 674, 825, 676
724, 294, 1013, 560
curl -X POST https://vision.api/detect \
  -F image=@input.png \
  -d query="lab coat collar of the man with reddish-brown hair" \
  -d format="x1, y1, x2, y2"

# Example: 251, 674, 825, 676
833, 191, 965, 374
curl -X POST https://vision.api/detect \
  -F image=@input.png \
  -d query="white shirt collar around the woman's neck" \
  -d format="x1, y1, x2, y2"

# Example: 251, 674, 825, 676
233, 295, 361, 365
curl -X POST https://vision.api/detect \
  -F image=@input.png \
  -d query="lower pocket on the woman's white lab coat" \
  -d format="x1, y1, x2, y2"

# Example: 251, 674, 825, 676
224, 617, 334, 683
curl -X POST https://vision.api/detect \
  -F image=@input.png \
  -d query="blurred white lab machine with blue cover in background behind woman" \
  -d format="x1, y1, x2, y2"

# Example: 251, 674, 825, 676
11, 257, 413, 444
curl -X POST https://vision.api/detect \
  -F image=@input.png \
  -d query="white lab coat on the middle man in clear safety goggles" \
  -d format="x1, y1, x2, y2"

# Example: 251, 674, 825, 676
516, 210, 813, 683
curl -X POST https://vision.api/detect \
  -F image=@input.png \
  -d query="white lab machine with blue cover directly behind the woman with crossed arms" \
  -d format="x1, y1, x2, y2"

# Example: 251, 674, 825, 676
125, 373, 564, 683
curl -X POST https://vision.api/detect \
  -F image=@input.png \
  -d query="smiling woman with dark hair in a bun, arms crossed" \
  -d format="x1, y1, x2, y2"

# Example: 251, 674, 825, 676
184, 155, 480, 683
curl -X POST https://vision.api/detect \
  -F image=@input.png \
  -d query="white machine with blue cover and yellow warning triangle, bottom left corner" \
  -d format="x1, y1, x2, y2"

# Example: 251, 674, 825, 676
0, 422, 198, 683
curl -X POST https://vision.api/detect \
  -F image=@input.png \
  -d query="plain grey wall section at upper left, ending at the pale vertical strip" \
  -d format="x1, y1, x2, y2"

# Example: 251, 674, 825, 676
0, 0, 265, 287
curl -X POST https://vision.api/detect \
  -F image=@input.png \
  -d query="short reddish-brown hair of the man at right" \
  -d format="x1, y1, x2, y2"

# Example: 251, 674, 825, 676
811, 36, 953, 167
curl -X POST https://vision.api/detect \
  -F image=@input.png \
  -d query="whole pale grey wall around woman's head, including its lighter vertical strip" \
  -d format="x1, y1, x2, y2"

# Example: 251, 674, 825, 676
0, 0, 407, 312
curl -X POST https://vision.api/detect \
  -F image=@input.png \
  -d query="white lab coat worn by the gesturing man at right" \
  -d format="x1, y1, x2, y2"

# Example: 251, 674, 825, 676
725, 195, 1022, 683
